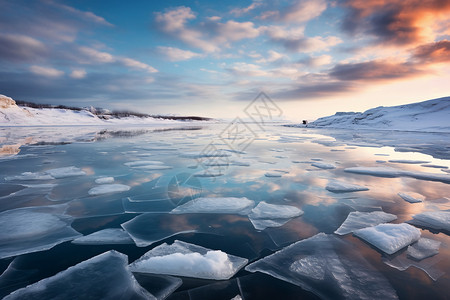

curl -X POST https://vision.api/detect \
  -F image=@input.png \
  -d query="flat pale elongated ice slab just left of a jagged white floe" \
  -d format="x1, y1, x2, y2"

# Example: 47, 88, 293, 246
171, 197, 255, 215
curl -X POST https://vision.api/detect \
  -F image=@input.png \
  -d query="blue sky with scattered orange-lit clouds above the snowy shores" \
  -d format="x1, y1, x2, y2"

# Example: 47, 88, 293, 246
0, 0, 450, 121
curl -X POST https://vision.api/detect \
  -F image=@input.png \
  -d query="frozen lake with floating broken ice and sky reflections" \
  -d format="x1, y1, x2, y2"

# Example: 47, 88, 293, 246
0, 124, 450, 299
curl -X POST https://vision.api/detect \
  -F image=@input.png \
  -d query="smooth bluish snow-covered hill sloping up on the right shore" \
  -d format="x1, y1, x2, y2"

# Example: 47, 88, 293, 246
308, 97, 450, 132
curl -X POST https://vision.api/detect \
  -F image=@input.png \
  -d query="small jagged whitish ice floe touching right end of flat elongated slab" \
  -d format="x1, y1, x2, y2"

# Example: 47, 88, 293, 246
248, 201, 303, 230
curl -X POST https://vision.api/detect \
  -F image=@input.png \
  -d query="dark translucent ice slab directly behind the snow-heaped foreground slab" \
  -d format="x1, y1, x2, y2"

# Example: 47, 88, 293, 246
120, 213, 199, 247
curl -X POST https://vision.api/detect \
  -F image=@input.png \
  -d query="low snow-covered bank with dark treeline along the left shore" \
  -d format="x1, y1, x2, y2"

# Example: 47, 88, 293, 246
0, 95, 207, 126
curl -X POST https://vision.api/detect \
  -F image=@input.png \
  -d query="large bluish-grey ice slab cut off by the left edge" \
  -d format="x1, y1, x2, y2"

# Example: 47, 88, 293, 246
0, 205, 81, 259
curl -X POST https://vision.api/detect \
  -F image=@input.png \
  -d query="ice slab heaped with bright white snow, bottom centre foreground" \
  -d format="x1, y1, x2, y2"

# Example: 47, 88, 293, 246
130, 240, 248, 280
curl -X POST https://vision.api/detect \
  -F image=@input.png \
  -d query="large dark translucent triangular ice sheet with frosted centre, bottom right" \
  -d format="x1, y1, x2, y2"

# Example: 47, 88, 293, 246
245, 233, 397, 300
